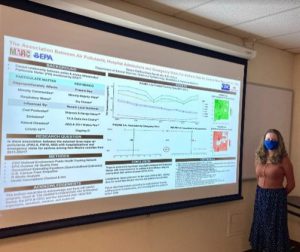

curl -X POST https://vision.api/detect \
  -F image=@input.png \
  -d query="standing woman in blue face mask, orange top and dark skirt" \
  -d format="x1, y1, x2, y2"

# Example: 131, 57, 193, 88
249, 129, 295, 252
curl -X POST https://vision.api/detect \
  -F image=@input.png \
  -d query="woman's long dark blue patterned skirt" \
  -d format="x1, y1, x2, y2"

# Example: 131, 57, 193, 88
249, 186, 289, 252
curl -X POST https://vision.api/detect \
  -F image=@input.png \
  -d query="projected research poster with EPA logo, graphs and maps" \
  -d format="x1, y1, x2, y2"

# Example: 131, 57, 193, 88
0, 36, 240, 210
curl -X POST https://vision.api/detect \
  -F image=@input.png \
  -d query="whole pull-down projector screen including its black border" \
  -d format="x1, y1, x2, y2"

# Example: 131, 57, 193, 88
0, 3, 247, 237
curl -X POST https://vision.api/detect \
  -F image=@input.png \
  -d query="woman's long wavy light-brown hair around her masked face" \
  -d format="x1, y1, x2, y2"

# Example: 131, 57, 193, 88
255, 129, 287, 164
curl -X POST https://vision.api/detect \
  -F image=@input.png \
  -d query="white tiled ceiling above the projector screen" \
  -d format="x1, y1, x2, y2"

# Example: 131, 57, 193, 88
32, 0, 300, 53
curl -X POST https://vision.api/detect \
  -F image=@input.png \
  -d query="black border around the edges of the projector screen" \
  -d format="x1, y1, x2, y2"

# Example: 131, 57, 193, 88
0, 0, 248, 238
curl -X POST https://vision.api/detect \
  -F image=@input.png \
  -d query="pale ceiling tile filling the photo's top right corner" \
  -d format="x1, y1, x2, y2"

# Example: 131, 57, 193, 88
176, 0, 300, 29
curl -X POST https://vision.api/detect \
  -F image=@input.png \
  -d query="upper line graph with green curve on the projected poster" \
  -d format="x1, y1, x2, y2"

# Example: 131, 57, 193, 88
114, 85, 201, 122
